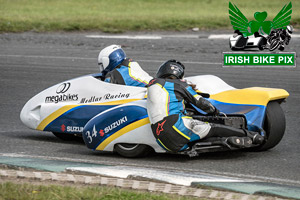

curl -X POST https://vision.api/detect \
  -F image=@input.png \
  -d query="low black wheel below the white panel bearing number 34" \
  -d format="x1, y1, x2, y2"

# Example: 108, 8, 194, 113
114, 143, 153, 158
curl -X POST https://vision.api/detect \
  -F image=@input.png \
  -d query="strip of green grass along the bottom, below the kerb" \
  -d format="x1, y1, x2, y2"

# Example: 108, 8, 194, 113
0, 182, 196, 200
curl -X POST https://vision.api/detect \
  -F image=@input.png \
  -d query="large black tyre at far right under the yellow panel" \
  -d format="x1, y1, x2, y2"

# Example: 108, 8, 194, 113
254, 101, 285, 151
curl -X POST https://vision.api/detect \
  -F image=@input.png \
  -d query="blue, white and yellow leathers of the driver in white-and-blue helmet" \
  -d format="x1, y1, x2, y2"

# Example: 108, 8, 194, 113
104, 58, 152, 87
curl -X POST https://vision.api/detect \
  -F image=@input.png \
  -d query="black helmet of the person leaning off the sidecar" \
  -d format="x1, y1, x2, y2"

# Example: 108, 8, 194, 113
156, 60, 185, 79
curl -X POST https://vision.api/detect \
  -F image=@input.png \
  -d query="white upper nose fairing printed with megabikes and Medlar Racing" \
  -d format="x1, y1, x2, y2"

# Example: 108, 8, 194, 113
20, 76, 146, 129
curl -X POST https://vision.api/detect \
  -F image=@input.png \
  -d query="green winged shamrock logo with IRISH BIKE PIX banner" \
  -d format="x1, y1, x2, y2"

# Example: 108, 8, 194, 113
223, 2, 296, 67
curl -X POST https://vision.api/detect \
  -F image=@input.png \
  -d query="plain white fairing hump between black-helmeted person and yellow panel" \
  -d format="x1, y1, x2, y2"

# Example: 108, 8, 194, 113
185, 75, 236, 94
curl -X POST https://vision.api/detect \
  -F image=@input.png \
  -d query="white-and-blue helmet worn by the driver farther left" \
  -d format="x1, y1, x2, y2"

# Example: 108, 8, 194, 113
98, 44, 126, 74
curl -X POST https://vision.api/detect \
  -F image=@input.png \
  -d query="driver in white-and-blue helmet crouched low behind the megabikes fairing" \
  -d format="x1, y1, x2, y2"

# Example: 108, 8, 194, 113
98, 45, 152, 87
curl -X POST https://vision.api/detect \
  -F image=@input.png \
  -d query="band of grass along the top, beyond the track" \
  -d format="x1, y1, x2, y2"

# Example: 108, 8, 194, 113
0, 0, 300, 32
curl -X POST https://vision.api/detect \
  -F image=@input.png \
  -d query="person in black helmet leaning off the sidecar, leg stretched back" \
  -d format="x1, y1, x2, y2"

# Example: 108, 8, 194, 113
147, 60, 264, 152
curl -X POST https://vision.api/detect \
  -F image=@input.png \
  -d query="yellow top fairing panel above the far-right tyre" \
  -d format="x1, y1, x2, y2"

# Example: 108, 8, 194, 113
210, 87, 289, 106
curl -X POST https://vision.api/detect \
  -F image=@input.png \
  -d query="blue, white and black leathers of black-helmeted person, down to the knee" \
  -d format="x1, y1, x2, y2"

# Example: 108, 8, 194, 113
147, 78, 215, 152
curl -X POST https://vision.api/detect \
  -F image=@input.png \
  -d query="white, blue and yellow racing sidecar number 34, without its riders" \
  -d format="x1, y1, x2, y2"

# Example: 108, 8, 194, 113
20, 74, 289, 157
